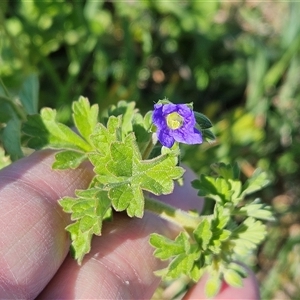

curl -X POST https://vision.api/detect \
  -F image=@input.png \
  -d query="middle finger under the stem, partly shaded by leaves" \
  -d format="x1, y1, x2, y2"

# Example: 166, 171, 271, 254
39, 171, 199, 299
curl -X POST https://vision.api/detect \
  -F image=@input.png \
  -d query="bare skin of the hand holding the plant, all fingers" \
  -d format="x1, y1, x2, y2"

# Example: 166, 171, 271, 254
0, 150, 259, 299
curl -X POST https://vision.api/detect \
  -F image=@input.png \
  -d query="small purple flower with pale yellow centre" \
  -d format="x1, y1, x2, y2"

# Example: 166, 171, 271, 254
152, 103, 203, 148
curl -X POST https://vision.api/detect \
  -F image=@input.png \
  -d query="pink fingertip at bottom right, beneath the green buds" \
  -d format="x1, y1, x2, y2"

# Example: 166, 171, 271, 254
184, 270, 260, 300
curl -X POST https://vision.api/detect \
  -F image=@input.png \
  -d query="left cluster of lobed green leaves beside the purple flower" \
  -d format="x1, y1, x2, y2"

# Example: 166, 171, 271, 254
23, 97, 184, 263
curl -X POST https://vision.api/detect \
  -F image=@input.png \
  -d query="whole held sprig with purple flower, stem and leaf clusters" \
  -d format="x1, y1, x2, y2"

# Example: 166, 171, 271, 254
23, 97, 272, 297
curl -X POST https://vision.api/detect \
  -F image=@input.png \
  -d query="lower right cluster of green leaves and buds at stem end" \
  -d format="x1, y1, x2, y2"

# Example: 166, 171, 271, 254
150, 163, 272, 297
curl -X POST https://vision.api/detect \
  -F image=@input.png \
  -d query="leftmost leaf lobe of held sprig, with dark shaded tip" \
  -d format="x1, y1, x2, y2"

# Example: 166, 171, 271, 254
23, 108, 91, 152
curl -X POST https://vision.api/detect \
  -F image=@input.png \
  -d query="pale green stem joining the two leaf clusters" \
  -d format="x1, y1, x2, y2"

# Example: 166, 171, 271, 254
145, 197, 203, 232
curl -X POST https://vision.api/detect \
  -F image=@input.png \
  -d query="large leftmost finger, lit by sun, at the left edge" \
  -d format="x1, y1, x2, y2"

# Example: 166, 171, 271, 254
0, 151, 92, 299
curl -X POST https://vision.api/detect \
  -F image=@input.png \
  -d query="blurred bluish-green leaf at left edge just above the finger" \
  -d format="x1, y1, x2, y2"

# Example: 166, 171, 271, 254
2, 118, 23, 161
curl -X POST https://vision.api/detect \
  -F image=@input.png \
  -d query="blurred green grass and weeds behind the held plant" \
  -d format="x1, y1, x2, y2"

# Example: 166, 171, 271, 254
0, 0, 300, 299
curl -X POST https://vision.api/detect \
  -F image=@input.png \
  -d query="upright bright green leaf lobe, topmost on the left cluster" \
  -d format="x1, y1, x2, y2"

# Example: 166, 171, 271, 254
72, 97, 99, 143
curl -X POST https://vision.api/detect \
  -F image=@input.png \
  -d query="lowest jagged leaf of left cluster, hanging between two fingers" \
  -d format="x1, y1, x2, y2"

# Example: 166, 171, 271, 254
59, 189, 111, 264
